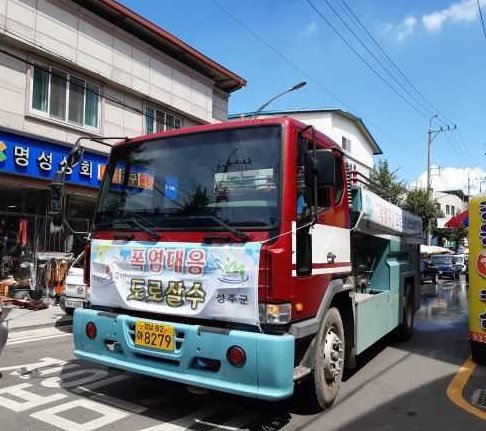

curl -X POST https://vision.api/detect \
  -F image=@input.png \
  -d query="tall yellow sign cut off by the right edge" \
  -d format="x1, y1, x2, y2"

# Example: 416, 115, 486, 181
469, 195, 486, 348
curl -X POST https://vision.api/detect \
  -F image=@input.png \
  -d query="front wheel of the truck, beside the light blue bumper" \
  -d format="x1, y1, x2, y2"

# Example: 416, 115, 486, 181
297, 307, 345, 410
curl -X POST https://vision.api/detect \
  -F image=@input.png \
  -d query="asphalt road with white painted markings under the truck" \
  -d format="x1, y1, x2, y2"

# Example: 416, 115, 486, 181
0, 279, 480, 431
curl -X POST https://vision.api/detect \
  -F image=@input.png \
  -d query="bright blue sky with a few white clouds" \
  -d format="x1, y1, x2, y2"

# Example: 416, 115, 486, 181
121, 0, 486, 189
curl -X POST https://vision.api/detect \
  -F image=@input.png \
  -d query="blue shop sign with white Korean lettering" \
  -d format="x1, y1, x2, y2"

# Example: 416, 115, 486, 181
0, 132, 107, 187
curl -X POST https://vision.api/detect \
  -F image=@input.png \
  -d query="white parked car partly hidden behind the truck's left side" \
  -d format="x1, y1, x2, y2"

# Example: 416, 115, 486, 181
59, 252, 89, 316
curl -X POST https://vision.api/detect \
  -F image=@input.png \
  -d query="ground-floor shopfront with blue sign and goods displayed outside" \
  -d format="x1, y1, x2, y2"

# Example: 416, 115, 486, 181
0, 131, 106, 297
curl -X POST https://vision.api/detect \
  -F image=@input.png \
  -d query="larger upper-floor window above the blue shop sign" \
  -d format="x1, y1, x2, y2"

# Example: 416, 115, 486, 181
31, 65, 100, 130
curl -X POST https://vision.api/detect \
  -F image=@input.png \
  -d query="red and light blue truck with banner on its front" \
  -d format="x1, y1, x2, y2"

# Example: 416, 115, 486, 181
74, 117, 420, 408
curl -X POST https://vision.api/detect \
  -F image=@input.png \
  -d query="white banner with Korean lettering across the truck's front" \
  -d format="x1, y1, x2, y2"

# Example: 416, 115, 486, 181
90, 239, 261, 325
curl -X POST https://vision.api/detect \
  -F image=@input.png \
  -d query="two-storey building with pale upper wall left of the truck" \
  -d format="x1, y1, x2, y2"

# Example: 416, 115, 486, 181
0, 0, 246, 275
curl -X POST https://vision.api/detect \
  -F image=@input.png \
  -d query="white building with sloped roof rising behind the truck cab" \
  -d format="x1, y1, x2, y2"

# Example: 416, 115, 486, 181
229, 109, 382, 176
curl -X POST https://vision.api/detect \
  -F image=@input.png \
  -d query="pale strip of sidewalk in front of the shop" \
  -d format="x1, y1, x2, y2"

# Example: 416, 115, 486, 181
5, 305, 72, 331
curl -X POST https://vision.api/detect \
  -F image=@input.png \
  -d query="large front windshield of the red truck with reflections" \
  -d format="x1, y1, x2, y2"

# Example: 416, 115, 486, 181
94, 126, 282, 230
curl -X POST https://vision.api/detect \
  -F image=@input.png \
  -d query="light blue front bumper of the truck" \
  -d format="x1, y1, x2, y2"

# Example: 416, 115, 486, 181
74, 309, 294, 400
